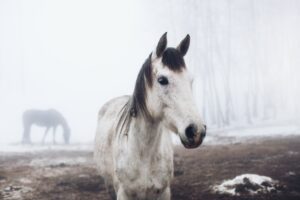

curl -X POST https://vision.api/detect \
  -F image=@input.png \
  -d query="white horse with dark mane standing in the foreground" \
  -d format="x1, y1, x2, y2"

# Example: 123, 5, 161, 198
94, 33, 206, 200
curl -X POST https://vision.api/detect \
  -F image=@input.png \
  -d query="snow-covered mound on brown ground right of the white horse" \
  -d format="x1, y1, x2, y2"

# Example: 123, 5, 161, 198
212, 174, 277, 195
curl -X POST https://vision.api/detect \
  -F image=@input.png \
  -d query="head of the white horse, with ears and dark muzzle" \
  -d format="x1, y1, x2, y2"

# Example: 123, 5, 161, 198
146, 33, 206, 148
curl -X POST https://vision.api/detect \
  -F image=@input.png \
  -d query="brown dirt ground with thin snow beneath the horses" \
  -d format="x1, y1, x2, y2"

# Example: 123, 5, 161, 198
0, 137, 300, 200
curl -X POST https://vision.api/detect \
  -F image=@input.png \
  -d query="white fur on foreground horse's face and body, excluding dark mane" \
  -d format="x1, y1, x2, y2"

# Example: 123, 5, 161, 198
94, 47, 203, 200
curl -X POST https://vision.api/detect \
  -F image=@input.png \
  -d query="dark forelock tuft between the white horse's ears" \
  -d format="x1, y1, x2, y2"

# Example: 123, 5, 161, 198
162, 48, 185, 72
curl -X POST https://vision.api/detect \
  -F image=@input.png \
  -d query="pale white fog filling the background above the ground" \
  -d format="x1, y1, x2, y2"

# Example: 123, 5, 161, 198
0, 0, 300, 143
